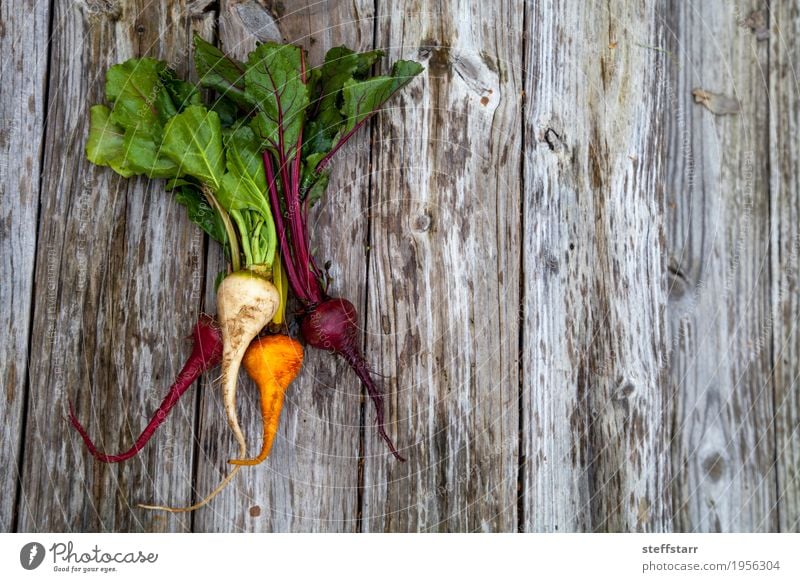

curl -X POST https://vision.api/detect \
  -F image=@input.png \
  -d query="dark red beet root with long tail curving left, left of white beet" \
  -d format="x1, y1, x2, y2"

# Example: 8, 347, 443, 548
69, 314, 222, 463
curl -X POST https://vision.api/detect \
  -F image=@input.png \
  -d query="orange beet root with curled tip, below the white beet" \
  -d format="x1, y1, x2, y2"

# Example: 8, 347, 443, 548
231, 335, 303, 465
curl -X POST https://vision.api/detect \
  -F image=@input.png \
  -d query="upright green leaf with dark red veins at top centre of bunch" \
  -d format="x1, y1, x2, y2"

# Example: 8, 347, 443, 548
245, 43, 308, 161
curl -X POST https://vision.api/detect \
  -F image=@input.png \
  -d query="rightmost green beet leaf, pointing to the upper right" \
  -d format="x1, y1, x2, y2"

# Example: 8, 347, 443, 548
339, 61, 423, 139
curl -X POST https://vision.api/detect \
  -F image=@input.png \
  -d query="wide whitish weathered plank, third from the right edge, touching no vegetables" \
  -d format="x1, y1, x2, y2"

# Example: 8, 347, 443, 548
522, 1, 670, 532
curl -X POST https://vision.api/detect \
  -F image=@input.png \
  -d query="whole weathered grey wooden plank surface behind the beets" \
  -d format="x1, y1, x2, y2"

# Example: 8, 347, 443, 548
0, 0, 800, 532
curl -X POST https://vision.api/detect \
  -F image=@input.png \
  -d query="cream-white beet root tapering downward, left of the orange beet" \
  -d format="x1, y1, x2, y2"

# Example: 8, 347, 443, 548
217, 271, 281, 458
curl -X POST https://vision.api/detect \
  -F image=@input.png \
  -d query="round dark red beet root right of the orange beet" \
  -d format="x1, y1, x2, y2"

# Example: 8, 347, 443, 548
300, 297, 405, 461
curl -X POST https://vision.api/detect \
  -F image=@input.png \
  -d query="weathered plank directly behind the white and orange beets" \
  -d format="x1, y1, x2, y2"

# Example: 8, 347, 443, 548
194, 0, 373, 532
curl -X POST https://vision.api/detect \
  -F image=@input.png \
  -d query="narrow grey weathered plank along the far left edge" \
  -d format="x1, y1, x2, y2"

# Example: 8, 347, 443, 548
0, 2, 50, 532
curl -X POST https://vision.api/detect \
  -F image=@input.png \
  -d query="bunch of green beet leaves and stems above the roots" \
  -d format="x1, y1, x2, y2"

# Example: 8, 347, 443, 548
86, 36, 422, 290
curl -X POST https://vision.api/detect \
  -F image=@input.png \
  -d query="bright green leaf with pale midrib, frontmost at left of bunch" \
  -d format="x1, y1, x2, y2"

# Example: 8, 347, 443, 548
162, 105, 225, 191
